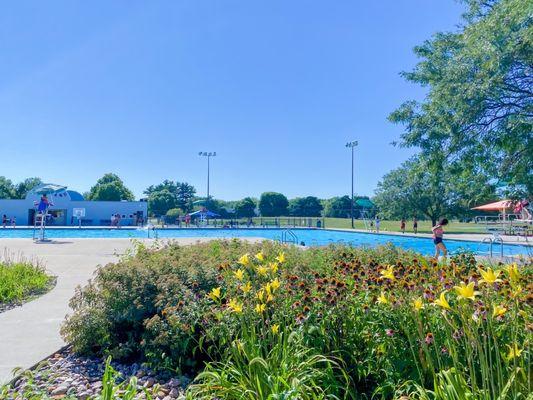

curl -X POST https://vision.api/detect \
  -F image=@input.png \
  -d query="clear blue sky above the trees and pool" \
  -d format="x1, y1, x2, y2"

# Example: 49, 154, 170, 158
0, 0, 463, 200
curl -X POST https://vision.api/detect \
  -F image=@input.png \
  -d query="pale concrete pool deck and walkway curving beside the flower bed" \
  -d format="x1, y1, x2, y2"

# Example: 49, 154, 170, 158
0, 238, 264, 385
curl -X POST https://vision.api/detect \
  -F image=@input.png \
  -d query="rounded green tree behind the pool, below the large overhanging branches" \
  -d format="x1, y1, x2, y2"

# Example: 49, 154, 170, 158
373, 156, 495, 225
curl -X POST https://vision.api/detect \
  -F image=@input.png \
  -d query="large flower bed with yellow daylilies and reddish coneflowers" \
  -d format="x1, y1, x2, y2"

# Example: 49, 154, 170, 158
59, 241, 532, 399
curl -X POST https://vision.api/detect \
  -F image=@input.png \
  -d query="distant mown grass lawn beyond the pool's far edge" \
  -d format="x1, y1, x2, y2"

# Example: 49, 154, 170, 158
325, 218, 487, 233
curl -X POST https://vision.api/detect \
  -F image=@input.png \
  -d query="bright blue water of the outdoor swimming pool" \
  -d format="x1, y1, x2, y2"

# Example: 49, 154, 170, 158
0, 228, 533, 255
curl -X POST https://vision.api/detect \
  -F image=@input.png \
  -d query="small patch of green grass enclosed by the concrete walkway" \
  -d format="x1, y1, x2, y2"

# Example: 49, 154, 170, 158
0, 261, 53, 306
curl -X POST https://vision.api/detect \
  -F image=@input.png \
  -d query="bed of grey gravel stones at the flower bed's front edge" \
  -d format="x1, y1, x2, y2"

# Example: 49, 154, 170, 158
4, 348, 190, 400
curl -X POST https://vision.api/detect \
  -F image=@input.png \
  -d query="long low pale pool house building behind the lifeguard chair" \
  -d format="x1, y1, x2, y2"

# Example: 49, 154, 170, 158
0, 184, 148, 226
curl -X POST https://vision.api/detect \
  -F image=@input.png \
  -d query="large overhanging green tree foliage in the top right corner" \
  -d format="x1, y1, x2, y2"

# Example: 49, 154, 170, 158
389, 0, 533, 193
